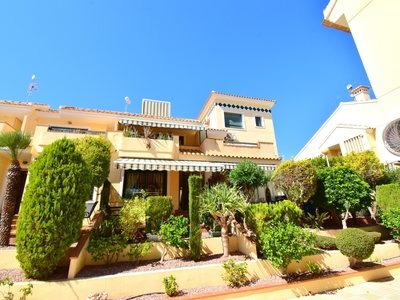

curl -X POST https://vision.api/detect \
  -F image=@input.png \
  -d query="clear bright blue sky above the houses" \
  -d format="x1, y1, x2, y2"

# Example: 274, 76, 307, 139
0, 0, 369, 159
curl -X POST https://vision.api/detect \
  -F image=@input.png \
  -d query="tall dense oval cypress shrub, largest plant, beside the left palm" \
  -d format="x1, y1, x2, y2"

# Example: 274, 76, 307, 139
17, 138, 91, 279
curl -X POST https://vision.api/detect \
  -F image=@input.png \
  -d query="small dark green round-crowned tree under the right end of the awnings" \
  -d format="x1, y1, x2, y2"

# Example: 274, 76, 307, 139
229, 160, 268, 200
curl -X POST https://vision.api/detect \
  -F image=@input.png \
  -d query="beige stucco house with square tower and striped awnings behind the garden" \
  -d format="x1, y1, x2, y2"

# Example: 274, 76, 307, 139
0, 92, 280, 210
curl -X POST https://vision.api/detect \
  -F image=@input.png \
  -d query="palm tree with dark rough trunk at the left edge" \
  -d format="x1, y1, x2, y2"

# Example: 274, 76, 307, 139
0, 131, 31, 246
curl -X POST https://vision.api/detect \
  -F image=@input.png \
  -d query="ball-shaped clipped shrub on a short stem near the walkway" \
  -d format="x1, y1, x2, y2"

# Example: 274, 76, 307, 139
336, 228, 375, 266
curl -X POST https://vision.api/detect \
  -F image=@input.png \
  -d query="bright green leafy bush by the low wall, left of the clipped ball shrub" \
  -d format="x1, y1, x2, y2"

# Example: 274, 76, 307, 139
260, 223, 315, 271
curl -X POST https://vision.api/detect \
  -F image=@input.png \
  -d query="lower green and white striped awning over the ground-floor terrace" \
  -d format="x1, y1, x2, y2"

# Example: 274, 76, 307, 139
114, 158, 276, 172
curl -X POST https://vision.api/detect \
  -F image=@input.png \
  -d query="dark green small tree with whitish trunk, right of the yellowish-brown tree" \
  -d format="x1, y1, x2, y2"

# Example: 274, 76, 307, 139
321, 166, 371, 228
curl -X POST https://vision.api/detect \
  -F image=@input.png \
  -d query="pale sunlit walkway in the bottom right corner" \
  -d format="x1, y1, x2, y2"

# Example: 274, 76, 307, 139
296, 277, 400, 300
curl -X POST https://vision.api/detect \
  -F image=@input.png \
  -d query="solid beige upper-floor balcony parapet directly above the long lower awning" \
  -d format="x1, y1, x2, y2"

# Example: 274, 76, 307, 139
107, 132, 179, 159
